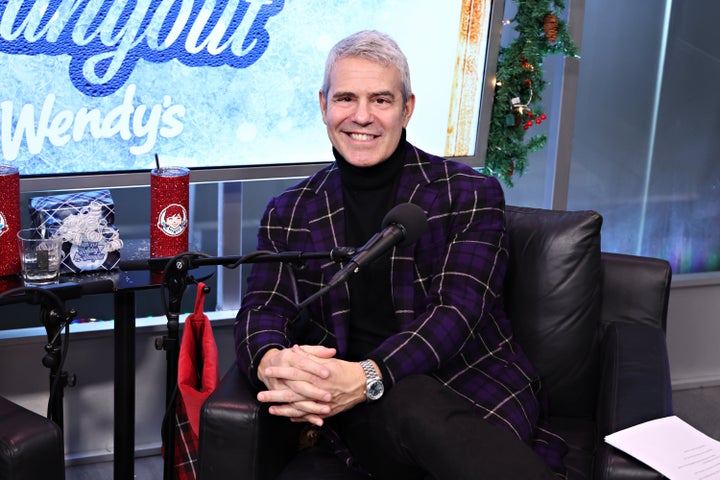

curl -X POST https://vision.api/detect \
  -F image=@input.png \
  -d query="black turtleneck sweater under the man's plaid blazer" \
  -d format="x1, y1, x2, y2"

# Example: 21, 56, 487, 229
333, 130, 406, 361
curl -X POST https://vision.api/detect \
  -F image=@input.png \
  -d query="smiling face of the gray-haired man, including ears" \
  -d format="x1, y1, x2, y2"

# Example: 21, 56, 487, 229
320, 57, 415, 167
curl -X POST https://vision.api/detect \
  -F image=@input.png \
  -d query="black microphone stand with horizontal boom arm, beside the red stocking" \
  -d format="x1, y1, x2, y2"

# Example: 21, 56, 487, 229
156, 247, 355, 480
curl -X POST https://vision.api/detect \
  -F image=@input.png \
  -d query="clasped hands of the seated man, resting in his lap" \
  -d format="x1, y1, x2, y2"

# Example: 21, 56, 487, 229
257, 345, 365, 426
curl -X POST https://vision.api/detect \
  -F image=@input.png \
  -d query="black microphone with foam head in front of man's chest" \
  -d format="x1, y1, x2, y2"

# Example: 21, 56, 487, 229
328, 203, 427, 287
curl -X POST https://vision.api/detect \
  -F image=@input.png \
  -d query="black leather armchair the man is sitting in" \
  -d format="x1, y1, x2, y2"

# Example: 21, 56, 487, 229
199, 206, 672, 480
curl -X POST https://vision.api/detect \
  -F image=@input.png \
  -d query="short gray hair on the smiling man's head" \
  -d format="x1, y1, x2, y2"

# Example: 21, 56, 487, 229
322, 30, 412, 103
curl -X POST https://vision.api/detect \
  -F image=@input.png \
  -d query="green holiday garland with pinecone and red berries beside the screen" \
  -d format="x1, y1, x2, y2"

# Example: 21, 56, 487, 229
483, 0, 577, 187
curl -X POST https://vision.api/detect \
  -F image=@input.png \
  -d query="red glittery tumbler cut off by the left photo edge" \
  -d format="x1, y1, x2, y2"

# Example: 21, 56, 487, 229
0, 164, 20, 276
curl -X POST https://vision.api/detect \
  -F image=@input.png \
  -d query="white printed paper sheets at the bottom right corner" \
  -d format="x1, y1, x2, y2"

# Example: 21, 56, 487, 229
605, 416, 720, 480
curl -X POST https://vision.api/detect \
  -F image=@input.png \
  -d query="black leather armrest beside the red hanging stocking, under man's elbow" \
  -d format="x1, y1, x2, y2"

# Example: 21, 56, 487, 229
198, 364, 300, 480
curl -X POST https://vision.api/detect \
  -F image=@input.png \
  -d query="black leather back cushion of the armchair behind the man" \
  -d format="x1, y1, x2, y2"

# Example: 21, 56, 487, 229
505, 206, 602, 417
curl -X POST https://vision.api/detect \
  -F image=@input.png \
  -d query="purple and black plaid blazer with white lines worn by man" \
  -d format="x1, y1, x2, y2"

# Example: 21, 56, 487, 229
235, 143, 564, 471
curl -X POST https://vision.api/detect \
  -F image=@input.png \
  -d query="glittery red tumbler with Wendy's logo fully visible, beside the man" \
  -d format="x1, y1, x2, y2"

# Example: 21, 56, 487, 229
150, 167, 190, 258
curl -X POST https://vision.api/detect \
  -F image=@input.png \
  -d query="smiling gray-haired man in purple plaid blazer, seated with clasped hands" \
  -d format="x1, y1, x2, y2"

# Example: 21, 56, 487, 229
235, 31, 564, 480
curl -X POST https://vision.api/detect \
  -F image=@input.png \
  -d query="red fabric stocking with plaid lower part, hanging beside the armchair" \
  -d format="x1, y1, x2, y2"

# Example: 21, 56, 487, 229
165, 283, 219, 480
